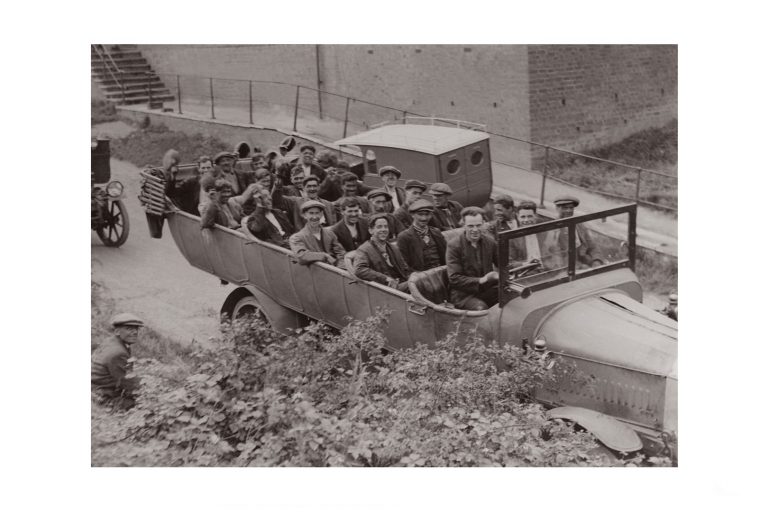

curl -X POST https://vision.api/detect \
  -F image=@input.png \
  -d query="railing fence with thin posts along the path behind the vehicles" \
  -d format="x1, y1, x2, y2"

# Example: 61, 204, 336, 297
152, 74, 677, 214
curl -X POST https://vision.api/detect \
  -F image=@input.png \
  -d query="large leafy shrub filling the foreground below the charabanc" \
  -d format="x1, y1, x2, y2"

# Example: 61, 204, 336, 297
93, 314, 668, 466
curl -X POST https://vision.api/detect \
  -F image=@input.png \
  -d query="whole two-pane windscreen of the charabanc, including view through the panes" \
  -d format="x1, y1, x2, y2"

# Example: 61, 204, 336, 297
498, 204, 637, 307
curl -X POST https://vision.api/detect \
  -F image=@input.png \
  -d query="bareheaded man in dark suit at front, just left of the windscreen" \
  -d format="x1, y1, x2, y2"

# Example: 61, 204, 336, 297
445, 206, 499, 311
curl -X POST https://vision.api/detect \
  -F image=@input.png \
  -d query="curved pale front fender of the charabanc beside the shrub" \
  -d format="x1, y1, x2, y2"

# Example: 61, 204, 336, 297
547, 407, 643, 453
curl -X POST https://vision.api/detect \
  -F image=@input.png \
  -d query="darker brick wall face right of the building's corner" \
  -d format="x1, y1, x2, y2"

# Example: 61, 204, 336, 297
528, 45, 677, 149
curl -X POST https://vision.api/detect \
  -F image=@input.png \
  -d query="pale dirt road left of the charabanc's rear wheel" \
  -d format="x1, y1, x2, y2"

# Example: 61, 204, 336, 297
91, 159, 234, 343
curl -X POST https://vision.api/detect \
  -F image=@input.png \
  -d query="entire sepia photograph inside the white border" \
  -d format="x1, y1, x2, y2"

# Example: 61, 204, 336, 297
90, 41, 690, 468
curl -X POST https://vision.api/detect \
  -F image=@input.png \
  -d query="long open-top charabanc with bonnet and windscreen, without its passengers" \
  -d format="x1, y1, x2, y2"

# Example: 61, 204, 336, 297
140, 125, 677, 460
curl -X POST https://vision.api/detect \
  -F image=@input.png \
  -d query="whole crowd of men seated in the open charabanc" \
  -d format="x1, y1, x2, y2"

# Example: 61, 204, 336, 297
163, 137, 601, 310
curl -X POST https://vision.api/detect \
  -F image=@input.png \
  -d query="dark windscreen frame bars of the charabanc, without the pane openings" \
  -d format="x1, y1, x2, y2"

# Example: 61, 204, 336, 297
497, 203, 637, 307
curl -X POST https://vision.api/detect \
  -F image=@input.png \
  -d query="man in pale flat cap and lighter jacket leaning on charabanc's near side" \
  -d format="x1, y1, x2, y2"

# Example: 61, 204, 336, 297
288, 199, 346, 268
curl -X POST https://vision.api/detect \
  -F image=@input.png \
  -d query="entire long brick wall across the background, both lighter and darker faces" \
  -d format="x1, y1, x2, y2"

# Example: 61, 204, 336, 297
139, 45, 677, 168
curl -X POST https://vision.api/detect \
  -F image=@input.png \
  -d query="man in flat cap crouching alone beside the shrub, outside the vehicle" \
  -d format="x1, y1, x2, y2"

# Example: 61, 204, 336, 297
91, 313, 144, 408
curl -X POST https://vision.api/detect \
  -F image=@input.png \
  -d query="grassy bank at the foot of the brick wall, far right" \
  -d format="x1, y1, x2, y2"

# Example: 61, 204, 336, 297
549, 120, 677, 212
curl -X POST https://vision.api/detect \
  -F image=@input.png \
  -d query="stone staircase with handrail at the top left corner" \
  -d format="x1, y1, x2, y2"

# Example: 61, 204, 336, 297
91, 44, 174, 109
